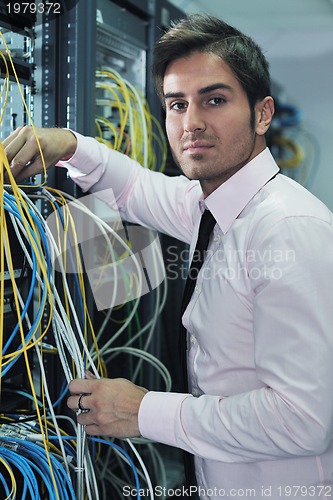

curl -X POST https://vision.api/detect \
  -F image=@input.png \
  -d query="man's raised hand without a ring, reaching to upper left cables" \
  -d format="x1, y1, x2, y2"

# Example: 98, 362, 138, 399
3, 126, 77, 181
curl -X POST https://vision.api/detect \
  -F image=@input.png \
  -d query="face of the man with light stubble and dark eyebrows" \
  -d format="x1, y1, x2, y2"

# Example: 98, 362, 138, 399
163, 52, 265, 196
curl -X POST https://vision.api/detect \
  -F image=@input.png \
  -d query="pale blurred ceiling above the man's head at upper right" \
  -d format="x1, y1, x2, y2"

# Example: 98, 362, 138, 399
169, 0, 333, 58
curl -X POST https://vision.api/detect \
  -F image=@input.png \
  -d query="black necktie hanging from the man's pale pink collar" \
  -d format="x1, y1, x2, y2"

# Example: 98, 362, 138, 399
179, 210, 216, 488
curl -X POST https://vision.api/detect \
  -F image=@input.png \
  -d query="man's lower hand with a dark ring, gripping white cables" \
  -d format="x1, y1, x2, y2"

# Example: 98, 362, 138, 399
67, 376, 148, 438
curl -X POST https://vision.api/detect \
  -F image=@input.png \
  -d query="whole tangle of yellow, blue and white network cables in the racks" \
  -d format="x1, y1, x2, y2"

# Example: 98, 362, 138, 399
0, 35, 171, 500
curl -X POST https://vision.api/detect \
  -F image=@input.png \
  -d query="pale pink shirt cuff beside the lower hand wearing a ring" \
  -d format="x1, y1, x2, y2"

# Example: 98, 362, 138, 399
138, 391, 192, 446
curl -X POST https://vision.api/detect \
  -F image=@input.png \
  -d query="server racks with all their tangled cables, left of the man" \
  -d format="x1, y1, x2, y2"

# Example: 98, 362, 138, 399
0, 0, 183, 500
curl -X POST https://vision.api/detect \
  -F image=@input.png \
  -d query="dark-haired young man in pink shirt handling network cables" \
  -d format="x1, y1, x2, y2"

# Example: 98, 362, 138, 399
5, 15, 333, 499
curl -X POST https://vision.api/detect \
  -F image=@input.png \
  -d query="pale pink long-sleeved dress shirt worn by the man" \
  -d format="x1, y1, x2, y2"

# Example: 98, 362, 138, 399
65, 135, 333, 500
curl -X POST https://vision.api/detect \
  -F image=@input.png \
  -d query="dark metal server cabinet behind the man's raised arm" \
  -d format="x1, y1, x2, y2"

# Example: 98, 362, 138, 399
40, 0, 182, 385
